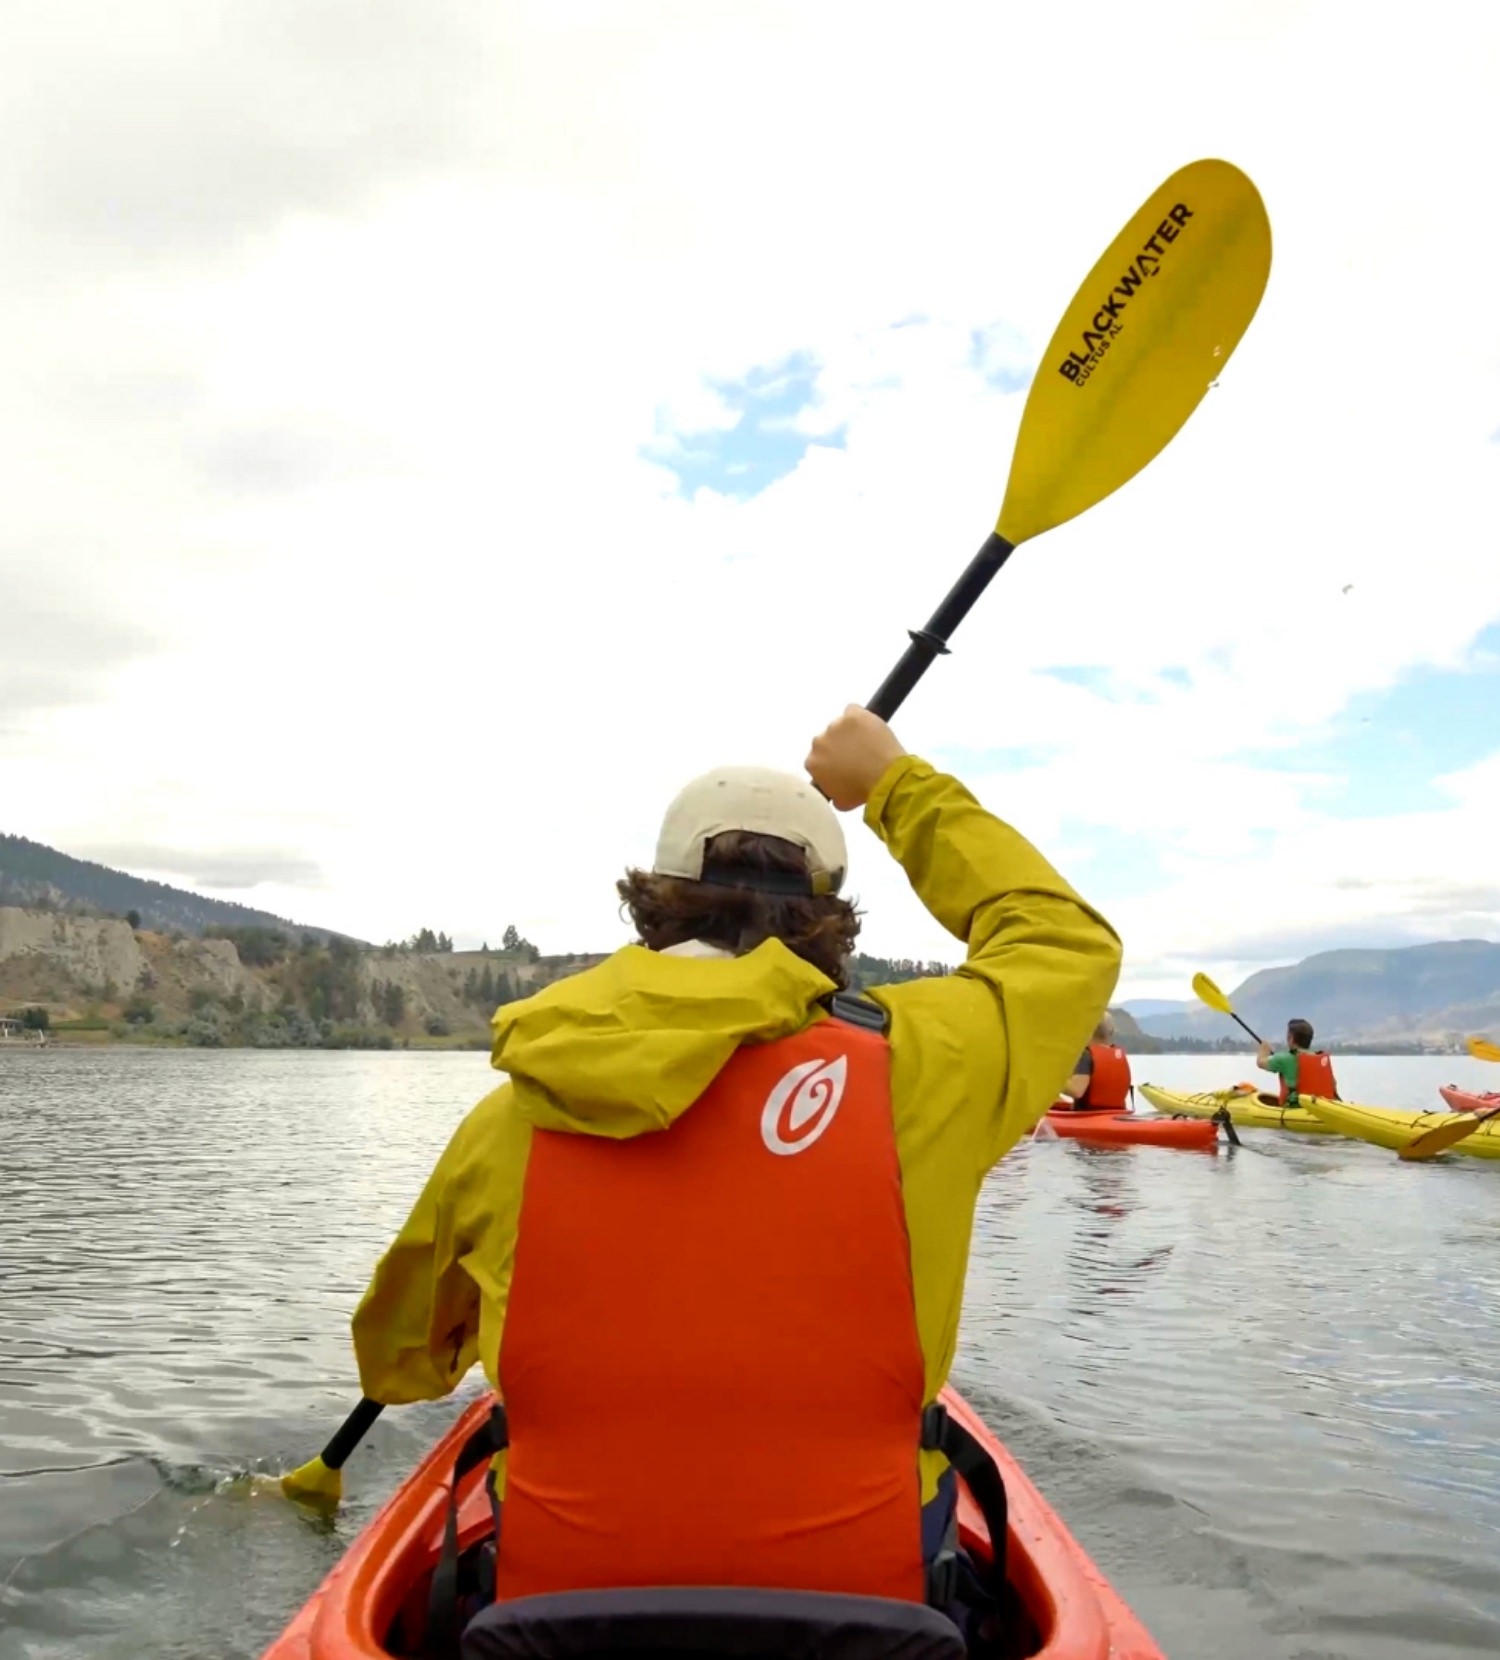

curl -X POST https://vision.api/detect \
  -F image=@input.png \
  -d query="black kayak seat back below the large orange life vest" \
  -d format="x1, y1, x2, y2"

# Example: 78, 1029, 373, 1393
461, 1585, 967, 1660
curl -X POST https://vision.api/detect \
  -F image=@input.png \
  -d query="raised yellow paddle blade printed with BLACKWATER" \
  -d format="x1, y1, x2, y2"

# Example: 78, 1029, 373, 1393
996, 161, 1271, 546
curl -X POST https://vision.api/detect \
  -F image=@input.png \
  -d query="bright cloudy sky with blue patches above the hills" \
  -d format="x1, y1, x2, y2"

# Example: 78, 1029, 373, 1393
0, 0, 1500, 996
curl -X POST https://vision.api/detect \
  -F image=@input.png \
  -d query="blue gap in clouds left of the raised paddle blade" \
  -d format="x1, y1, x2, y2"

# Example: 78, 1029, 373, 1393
647, 350, 849, 501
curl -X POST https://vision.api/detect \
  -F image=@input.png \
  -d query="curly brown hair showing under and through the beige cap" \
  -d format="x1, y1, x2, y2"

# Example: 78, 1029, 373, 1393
616, 830, 860, 991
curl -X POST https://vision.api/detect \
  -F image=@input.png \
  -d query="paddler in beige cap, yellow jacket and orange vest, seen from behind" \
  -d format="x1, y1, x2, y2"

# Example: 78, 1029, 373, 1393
353, 707, 1120, 1626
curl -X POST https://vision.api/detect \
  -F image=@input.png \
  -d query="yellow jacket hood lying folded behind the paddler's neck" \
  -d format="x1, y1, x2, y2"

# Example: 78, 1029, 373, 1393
489, 940, 838, 1140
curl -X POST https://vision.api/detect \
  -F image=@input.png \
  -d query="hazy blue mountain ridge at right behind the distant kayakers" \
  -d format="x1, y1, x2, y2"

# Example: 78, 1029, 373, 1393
1140, 940, 1500, 1044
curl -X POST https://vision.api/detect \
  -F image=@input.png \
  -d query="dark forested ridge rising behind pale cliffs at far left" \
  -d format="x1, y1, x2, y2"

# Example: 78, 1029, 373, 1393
0, 835, 345, 941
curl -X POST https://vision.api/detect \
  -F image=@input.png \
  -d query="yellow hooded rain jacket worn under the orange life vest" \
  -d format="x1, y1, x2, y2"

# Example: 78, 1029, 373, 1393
353, 755, 1120, 1502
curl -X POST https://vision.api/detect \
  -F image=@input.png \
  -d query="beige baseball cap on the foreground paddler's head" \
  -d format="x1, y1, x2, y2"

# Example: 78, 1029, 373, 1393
652, 767, 850, 893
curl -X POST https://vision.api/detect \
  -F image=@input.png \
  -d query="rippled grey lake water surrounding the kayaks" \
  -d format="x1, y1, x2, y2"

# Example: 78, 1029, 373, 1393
0, 1049, 1500, 1660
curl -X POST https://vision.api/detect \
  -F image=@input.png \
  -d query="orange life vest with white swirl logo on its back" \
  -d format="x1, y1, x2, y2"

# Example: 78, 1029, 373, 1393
496, 996, 926, 1602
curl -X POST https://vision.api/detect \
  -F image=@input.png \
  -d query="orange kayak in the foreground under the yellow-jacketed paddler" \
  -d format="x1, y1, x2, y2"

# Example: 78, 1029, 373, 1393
262, 1389, 1166, 1660
